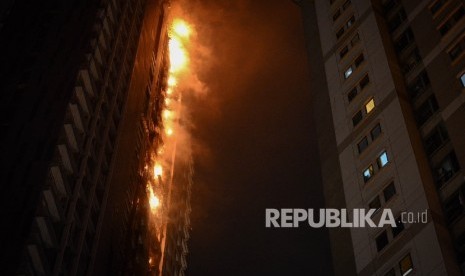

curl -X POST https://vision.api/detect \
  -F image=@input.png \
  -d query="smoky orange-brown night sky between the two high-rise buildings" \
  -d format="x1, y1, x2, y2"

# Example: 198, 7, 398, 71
178, 0, 331, 276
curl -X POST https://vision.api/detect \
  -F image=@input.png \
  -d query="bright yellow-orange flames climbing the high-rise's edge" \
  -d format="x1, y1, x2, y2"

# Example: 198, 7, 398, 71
147, 19, 191, 214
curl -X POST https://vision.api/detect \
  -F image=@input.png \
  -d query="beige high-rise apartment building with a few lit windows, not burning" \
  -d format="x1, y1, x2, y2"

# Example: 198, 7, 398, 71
294, 0, 465, 275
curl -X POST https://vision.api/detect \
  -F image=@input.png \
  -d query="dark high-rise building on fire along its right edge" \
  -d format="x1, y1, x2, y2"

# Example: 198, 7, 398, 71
0, 0, 192, 275
